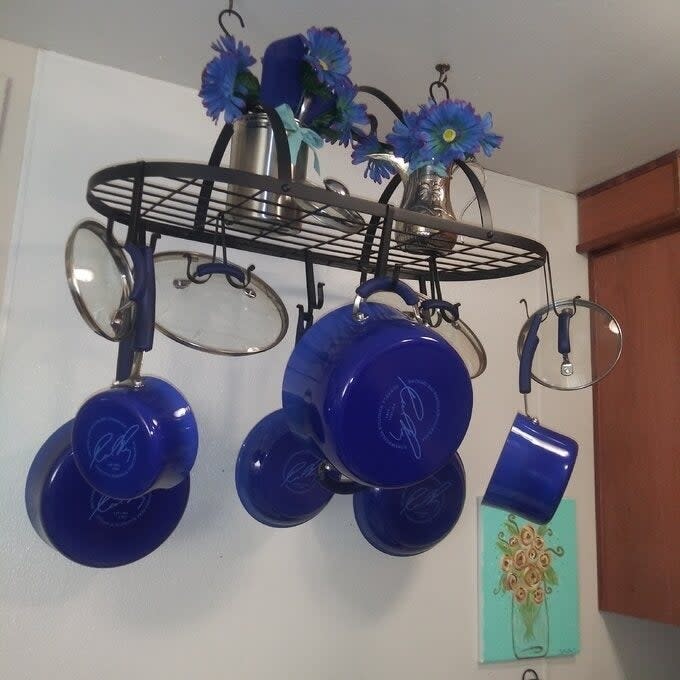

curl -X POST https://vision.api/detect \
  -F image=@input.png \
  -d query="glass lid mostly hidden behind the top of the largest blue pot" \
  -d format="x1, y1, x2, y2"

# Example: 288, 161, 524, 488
371, 292, 487, 378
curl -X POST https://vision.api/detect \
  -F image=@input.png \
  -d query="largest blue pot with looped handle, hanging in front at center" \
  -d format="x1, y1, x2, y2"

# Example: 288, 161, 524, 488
283, 278, 472, 488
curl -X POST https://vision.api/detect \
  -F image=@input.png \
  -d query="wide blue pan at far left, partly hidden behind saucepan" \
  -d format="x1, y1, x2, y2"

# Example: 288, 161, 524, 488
25, 421, 190, 567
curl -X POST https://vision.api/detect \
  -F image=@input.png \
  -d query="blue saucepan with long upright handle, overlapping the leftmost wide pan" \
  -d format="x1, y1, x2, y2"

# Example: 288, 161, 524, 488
73, 245, 198, 499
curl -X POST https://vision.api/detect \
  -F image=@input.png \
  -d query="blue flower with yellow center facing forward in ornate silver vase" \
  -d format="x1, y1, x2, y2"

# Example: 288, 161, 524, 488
420, 99, 484, 165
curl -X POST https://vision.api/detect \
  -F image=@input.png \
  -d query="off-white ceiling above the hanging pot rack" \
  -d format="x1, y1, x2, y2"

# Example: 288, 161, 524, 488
0, 0, 680, 192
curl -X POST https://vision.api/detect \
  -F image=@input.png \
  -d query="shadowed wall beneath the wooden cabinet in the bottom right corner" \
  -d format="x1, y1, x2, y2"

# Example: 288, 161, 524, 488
602, 614, 680, 680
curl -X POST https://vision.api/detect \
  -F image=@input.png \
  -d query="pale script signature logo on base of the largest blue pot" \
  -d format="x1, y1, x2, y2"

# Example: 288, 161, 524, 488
378, 377, 439, 460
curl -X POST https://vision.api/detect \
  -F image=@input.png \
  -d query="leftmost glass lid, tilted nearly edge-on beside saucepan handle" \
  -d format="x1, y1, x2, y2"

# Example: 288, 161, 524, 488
65, 220, 134, 341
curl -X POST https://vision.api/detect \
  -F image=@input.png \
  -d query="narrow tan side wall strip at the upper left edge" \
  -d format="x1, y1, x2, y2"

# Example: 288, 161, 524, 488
0, 39, 38, 310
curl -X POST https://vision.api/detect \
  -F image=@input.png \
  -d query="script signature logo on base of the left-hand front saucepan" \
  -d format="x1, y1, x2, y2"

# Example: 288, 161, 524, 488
87, 416, 139, 477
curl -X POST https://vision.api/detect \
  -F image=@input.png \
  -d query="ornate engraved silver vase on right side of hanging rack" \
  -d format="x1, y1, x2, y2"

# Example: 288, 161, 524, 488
394, 165, 458, 255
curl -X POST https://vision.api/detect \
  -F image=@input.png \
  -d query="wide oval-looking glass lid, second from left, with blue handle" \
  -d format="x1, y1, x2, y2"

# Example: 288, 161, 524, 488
154, 251, 288, 356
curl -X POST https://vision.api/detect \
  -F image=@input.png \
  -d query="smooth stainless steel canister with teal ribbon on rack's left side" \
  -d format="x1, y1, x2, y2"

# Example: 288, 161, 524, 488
224, 113, 308, 235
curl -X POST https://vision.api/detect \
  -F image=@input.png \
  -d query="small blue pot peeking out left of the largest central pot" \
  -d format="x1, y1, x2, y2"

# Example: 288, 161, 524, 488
236, 410, 333, 527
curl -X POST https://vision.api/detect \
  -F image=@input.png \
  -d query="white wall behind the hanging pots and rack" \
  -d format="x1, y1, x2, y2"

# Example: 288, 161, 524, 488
0, 53, 680, 680
